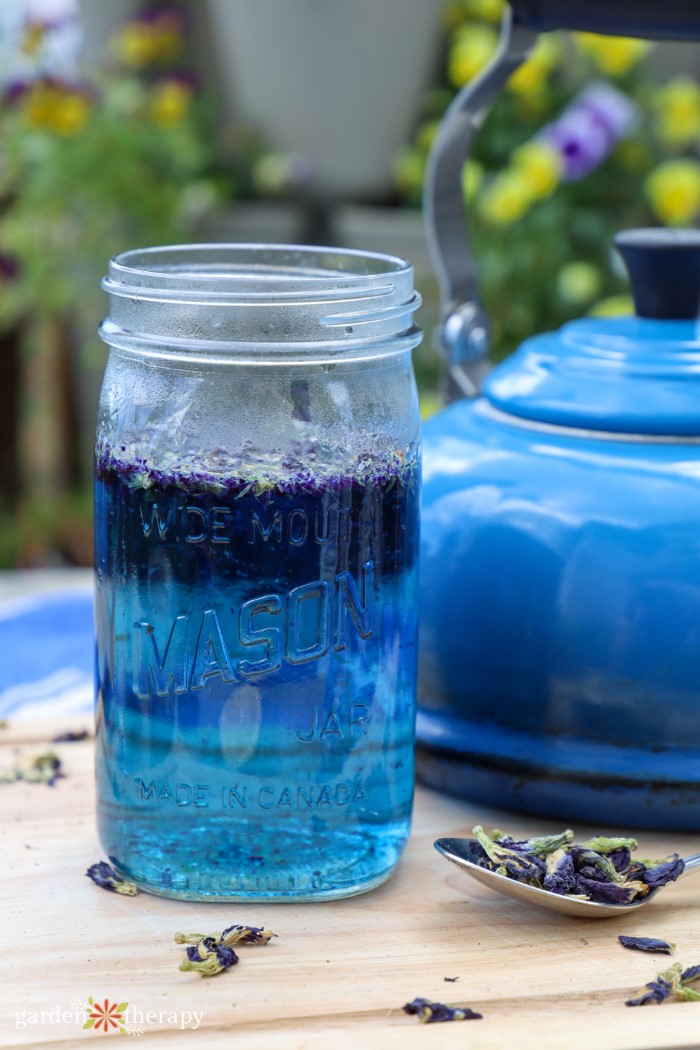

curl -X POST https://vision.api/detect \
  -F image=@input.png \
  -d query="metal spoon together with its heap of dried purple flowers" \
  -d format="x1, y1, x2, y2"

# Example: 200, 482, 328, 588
434, 824, 700, 919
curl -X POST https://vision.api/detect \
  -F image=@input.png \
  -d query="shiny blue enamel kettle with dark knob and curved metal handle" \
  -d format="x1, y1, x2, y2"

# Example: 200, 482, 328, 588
417, 0, 700, 831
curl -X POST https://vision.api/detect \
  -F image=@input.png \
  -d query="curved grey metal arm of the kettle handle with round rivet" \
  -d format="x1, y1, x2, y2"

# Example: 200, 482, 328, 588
423, 10, 537, 400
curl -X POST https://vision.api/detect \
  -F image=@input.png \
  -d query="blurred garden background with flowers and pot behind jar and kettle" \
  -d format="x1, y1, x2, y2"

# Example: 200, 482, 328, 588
0, 0, 700, 568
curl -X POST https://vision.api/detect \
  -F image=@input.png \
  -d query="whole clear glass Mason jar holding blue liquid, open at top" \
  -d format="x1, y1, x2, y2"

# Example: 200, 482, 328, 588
96, 245, 420, 900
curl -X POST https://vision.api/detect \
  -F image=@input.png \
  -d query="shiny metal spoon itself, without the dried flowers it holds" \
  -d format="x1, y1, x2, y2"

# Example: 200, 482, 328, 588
434, 839, 700, 919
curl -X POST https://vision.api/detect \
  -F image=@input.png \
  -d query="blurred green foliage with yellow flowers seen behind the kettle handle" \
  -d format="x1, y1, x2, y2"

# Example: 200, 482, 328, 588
396, 0, 700, 359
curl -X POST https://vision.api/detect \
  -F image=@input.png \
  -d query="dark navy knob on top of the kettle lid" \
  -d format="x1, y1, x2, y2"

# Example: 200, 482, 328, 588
614, 229, 700, 320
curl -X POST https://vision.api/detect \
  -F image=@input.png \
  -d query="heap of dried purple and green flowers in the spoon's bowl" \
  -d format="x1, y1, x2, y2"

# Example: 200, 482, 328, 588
472, 824, 684, 904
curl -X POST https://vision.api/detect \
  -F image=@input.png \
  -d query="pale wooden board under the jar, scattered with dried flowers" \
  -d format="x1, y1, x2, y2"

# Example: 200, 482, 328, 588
0, 721, 700, 1050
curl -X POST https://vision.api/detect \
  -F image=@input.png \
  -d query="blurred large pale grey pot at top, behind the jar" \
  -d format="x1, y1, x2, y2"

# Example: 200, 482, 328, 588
208, 0, 443, 201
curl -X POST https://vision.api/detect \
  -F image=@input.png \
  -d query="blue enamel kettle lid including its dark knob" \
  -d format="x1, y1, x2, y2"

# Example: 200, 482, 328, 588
484, 229, 700, 437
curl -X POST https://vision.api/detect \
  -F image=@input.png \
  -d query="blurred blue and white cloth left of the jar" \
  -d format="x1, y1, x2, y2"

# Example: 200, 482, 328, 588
0, 590, 94, 718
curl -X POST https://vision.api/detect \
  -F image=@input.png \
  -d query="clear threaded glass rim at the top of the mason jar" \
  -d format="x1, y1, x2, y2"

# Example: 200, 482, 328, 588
100, 244, 421, 364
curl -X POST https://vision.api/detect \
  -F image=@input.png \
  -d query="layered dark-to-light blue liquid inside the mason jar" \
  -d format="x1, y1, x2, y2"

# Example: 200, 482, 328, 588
96, 447, 419, 900
